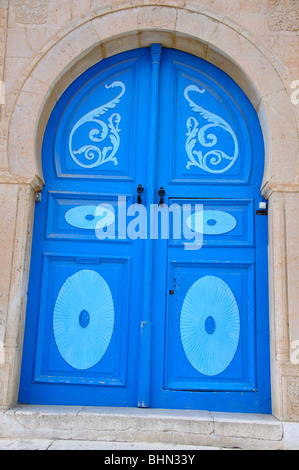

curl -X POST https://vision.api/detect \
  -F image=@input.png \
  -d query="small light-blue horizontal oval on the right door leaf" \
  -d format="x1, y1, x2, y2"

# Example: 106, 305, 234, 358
186, 210, 237, 235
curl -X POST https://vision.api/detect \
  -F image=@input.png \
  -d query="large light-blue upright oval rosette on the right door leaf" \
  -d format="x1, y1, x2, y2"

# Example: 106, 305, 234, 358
180, 276, 240, 376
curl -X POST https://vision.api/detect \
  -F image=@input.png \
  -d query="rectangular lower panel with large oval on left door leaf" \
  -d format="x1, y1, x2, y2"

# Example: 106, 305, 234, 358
34, 255, 130, 387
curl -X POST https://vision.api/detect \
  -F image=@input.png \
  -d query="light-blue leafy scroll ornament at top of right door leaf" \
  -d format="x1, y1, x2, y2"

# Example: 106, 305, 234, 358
184, 85, 239, 174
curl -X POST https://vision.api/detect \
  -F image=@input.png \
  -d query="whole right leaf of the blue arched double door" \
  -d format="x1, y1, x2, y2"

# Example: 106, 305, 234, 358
151, 50, 271, 413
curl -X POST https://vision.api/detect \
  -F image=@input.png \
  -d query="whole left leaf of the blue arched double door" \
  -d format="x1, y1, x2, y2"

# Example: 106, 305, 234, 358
19, 49, 151, 406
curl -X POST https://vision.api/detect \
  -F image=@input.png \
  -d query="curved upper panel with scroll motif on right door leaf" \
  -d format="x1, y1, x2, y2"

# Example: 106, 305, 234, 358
160, 51, 252, 185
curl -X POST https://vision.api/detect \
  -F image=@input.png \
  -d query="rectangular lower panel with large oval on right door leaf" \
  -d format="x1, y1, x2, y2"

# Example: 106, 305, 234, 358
164, 261, 255, 391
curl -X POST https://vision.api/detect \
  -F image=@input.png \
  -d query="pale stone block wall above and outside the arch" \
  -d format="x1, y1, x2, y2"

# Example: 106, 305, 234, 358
0, 0, 299, 101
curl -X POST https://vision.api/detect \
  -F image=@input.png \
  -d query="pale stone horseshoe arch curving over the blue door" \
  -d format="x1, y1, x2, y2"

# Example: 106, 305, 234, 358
8, 5, 298, 195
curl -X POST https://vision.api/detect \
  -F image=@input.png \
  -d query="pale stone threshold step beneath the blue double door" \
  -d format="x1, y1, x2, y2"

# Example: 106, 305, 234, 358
0, 405, 292, 450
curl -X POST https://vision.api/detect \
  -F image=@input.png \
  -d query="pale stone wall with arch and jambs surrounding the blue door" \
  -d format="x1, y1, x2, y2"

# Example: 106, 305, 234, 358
0, 0, 299, 420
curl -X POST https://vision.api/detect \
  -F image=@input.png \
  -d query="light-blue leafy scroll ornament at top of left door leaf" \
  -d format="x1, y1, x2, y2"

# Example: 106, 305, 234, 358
69, 81, 126, 168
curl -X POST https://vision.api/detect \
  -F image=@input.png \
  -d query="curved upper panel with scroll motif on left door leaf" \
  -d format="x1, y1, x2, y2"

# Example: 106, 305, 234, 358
55, 57, 141, 181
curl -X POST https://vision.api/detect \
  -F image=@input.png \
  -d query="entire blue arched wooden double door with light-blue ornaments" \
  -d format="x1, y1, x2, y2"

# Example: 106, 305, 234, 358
20, 45, 271, 413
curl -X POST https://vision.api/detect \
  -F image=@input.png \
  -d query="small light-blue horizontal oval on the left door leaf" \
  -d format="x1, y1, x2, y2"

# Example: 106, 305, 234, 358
64, 205, 115, 230
